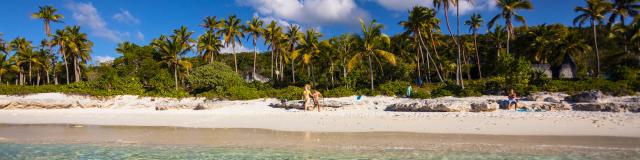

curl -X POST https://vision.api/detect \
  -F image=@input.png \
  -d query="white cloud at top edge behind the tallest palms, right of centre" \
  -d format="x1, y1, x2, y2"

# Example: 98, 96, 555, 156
376, 0, 497, 15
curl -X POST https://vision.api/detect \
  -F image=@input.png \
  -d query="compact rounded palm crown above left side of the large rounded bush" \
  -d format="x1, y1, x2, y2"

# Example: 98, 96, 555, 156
196, 30, 224, 63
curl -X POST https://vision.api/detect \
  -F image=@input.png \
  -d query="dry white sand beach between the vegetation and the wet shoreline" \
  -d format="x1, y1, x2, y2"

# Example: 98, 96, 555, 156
0, 94, 640, 137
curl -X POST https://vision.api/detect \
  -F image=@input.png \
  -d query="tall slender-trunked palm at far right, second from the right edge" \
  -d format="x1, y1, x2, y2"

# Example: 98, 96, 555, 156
573, 0, 612, 77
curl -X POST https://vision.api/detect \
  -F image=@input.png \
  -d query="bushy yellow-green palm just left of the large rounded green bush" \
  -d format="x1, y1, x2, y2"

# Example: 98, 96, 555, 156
151, 26, 194, 90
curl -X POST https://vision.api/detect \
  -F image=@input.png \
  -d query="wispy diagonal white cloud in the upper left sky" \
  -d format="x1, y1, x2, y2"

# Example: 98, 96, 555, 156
66, 1, 129, 42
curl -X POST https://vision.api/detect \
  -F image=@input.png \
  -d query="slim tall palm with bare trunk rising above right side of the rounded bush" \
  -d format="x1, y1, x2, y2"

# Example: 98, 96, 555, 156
218, 15, 244, 73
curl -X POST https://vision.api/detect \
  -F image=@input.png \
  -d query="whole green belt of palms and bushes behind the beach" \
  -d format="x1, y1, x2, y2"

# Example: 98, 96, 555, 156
0, 0, 640, 99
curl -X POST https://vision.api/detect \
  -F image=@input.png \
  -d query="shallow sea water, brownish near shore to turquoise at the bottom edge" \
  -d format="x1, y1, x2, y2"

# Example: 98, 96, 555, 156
0, 124, 640, 160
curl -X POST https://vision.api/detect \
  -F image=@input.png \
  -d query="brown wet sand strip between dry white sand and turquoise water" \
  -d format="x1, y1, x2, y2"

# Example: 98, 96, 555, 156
0, 124, 640, 155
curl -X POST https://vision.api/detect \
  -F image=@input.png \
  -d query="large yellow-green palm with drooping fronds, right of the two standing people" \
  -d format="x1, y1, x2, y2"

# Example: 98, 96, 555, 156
348, 19, 396, 91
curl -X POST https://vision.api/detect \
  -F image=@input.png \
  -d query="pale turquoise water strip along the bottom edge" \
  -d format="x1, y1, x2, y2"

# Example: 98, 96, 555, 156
0, 143, 640, 160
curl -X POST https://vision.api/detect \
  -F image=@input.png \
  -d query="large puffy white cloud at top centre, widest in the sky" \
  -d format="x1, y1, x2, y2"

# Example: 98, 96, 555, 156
236, 0, 367, 26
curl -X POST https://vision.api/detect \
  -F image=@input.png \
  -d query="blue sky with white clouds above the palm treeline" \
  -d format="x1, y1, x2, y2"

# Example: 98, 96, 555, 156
0, 0, 585, 63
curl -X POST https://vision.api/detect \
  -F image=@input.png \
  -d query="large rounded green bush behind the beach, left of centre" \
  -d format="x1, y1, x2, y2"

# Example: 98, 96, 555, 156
188, 62, 244, 93
